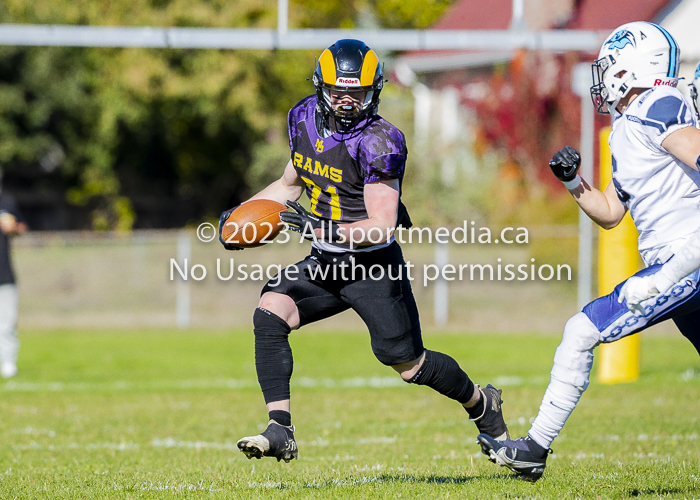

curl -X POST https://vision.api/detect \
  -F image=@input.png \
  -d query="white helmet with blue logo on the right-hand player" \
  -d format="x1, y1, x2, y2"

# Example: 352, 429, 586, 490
591, 21, 681, 116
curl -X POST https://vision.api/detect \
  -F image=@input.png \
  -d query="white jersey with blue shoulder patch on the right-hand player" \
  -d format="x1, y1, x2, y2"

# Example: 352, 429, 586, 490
610, 87, 700, 265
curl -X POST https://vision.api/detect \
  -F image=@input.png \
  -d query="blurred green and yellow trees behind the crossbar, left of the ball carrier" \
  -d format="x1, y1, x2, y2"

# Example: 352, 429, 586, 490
0, 0, 456, 229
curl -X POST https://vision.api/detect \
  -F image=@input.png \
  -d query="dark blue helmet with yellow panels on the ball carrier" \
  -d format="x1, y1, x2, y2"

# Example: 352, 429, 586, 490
313, 39, 384, 129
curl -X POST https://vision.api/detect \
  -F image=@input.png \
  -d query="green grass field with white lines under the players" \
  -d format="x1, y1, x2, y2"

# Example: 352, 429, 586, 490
0, 330, 700, 499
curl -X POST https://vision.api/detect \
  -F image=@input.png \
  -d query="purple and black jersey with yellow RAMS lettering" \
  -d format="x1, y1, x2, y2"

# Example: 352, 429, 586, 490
287, 95, 407, 226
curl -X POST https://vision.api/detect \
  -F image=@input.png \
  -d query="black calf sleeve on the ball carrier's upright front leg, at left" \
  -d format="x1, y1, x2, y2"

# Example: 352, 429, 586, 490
253, 307, 294, 403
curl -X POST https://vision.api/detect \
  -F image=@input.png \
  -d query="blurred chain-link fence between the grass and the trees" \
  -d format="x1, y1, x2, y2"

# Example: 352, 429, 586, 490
13, 226, 640, 333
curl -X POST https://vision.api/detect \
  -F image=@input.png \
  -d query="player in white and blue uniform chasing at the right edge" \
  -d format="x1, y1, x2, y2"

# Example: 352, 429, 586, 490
477, 22, 700, 482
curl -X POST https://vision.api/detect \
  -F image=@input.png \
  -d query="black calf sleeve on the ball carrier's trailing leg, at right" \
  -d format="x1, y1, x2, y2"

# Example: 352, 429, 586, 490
406, 349, 474, 404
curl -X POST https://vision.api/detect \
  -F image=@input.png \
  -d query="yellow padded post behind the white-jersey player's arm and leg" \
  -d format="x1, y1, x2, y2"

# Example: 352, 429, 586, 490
598, 127, 641, 384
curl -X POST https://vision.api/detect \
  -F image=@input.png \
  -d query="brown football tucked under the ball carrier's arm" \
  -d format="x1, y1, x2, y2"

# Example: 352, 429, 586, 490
221, 200, 287, 248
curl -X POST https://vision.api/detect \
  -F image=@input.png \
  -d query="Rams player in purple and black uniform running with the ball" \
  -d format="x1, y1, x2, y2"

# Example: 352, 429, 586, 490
220, 40, 508, 461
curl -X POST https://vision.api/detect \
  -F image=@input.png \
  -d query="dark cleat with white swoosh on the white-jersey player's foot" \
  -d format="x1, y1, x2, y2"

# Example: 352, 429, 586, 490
476, 434, 552, 483
